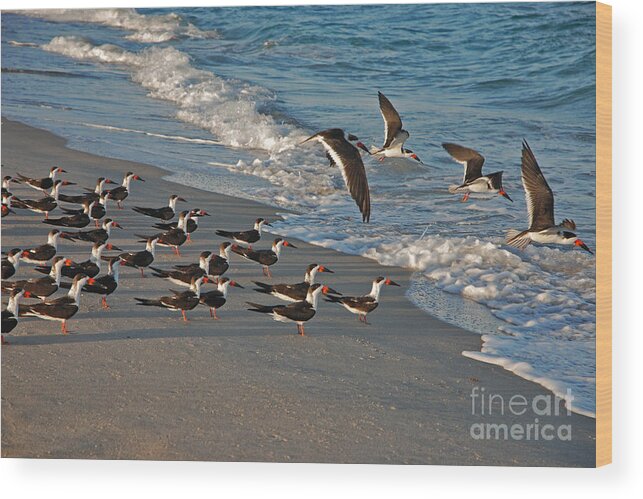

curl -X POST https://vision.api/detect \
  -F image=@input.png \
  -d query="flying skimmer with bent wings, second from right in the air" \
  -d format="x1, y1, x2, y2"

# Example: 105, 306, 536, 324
442, 143, 513, 202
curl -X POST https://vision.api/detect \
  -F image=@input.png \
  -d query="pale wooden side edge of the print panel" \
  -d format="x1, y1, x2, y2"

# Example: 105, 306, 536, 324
596, 2, 612, 467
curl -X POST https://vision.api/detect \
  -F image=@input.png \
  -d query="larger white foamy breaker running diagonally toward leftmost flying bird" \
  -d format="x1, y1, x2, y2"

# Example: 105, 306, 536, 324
42, 36, 304, 153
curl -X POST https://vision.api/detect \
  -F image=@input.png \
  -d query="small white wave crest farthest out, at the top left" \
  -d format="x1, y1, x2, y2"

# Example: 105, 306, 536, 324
18, 9, 218, 43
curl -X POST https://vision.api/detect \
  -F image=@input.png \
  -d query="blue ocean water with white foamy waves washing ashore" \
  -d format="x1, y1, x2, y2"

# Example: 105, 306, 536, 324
2, 3, 596, 415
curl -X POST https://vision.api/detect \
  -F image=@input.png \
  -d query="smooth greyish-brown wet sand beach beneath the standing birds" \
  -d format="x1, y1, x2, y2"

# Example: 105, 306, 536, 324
2, 119, 595, 466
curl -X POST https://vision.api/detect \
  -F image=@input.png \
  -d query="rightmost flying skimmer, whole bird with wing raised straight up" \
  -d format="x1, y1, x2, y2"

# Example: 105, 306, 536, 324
506, 141, 593, 254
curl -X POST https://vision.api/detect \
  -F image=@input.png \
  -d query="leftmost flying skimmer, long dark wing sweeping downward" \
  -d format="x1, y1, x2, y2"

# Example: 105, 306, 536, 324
302, 128, 371, 222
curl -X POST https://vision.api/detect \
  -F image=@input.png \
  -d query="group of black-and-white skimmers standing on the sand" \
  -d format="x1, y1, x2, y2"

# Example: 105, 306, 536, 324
2, 167, 399, 344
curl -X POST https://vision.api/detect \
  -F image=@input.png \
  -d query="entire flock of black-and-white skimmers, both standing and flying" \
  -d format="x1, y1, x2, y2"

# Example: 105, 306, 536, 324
2, 92, 592, 342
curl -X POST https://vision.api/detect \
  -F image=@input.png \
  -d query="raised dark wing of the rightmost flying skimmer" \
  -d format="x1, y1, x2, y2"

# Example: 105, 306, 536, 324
522, 141, 556, 230
